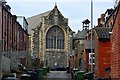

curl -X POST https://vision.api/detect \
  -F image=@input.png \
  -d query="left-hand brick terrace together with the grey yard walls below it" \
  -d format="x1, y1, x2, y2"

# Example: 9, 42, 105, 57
0, 0, 29, 78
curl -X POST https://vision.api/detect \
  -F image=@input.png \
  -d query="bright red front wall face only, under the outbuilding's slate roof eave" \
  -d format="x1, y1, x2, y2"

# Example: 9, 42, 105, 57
98, 41, 110, 78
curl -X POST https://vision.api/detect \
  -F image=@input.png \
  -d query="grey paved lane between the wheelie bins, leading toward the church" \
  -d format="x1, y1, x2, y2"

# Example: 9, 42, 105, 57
45, 71, 72, 80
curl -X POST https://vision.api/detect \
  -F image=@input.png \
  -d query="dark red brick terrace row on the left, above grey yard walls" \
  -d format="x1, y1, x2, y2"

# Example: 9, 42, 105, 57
0, 2, 29, 52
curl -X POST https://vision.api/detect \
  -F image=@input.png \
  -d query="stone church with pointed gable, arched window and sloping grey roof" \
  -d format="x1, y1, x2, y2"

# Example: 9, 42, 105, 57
27, 5, 73, 67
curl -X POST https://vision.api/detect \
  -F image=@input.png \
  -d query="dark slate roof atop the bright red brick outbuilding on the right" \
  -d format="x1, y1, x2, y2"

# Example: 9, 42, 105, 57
95, 27, 111, 39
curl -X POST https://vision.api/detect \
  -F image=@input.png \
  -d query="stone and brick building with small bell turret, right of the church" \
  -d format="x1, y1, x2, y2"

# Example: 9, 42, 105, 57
74, 19, 90, 72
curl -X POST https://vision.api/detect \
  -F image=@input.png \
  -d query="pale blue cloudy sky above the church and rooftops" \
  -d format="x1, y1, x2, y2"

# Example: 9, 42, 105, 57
6, 0, 115, 32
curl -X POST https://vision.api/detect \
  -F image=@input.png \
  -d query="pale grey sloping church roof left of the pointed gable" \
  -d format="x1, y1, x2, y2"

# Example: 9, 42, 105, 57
27, 10, 51, 33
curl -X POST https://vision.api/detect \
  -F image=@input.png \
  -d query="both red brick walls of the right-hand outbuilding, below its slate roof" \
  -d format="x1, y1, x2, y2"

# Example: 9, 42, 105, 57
94, 29, 110, 78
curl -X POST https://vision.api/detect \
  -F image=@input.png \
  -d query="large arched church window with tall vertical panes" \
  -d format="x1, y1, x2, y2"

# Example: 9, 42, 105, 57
46, 26, 64, 49
